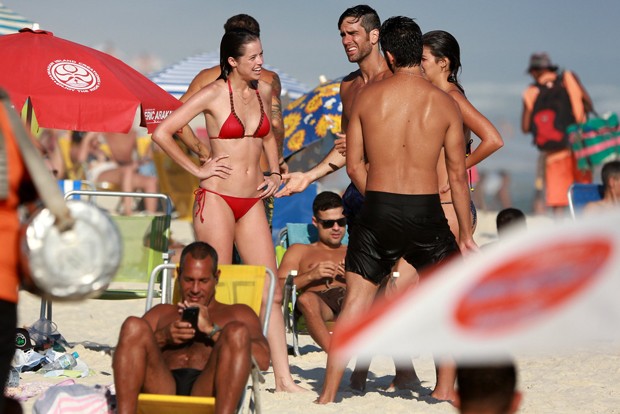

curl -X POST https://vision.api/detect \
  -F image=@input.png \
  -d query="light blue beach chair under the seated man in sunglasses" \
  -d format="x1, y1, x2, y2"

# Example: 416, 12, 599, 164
276, 223, 349, 356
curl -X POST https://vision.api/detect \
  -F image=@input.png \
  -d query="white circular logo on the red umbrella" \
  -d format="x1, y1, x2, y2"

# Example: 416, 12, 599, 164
47, 60, 101, 92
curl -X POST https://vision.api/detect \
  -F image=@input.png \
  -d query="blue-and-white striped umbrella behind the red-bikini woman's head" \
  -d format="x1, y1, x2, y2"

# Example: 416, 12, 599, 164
149, 51, 309, 99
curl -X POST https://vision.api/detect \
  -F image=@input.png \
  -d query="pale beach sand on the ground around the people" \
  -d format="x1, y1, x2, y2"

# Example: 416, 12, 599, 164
9, 212, 620, 414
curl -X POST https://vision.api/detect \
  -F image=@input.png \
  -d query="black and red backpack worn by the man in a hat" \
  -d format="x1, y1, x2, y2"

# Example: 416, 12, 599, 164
531, 73, 575, 151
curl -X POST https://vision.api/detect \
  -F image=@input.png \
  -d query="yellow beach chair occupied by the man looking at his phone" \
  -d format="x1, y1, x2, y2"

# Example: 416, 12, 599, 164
144, 263, 277, 414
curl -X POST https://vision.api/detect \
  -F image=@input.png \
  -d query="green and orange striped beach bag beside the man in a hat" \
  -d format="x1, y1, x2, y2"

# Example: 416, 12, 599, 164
567, 113, 620, 170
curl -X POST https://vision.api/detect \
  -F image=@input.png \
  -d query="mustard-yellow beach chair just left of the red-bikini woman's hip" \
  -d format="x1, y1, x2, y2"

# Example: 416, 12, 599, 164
153, 151, 200, 221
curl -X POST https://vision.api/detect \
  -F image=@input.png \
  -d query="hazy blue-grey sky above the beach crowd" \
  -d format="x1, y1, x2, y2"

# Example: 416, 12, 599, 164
0, 0, 620, 210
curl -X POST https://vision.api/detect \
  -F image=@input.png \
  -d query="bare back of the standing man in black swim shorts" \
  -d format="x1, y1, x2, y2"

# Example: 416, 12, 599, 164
349, 71, 465, 194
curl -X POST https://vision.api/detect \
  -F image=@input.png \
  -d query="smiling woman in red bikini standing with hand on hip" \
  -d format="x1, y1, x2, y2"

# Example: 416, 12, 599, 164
153, 29, 303, 392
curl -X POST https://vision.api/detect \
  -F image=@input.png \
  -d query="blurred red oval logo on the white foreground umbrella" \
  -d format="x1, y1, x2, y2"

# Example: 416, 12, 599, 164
454, 239, 612, 334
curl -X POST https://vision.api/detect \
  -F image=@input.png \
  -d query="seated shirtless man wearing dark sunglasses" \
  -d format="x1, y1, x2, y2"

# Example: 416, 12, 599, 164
278, 191, 347, 352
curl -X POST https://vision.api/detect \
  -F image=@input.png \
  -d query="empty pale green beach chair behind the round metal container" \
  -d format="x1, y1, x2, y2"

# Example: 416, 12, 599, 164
41, 190, 172, 322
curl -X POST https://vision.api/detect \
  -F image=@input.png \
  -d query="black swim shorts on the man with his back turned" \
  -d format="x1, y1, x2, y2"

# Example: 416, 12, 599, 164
345, 191, 459, 285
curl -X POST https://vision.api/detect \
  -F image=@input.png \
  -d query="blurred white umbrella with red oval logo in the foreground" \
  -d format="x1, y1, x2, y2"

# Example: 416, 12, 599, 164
332, 210, 620, 362
